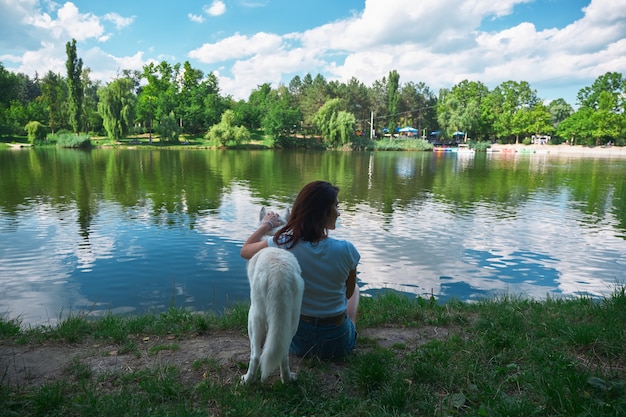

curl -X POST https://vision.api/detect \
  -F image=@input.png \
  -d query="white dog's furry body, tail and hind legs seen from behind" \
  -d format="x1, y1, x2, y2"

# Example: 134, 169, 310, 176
241, 247, 304, 383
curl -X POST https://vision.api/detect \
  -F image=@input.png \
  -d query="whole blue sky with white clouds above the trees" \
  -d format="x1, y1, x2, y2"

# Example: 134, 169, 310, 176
0, 0, 626, 106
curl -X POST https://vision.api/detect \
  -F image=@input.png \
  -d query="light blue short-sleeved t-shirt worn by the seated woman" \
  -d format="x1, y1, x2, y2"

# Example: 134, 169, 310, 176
268, 237, 361, 317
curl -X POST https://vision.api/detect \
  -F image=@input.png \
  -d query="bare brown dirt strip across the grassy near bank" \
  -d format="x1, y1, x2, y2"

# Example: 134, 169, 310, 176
0, 326, 448, 386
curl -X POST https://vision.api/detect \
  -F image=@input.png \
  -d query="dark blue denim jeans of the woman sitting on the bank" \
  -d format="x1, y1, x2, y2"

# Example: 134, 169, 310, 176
289, 317, 357, 359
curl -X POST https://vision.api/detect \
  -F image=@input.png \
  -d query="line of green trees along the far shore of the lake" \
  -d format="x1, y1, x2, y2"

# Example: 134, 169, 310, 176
0, 39, 626, 147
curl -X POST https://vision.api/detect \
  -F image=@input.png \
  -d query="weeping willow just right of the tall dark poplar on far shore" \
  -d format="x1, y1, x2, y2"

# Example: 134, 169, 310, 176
98, 78, 136, 141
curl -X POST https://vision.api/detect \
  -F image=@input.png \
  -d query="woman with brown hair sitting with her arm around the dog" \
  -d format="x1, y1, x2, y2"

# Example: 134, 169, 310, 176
241, 181, 361, 359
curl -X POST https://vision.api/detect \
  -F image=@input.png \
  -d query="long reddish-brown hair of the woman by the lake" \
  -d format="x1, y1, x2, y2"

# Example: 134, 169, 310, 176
274, 181, 339, 248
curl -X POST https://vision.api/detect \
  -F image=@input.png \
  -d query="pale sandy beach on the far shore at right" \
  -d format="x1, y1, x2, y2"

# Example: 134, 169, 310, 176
491, 144, 626, 158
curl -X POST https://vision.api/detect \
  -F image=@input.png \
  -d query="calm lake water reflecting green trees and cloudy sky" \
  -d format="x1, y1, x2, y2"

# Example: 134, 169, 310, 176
0, 149, 626, 324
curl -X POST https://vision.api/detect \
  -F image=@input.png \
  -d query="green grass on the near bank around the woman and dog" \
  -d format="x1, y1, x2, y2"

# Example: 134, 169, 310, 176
0, 288, 626, 417
